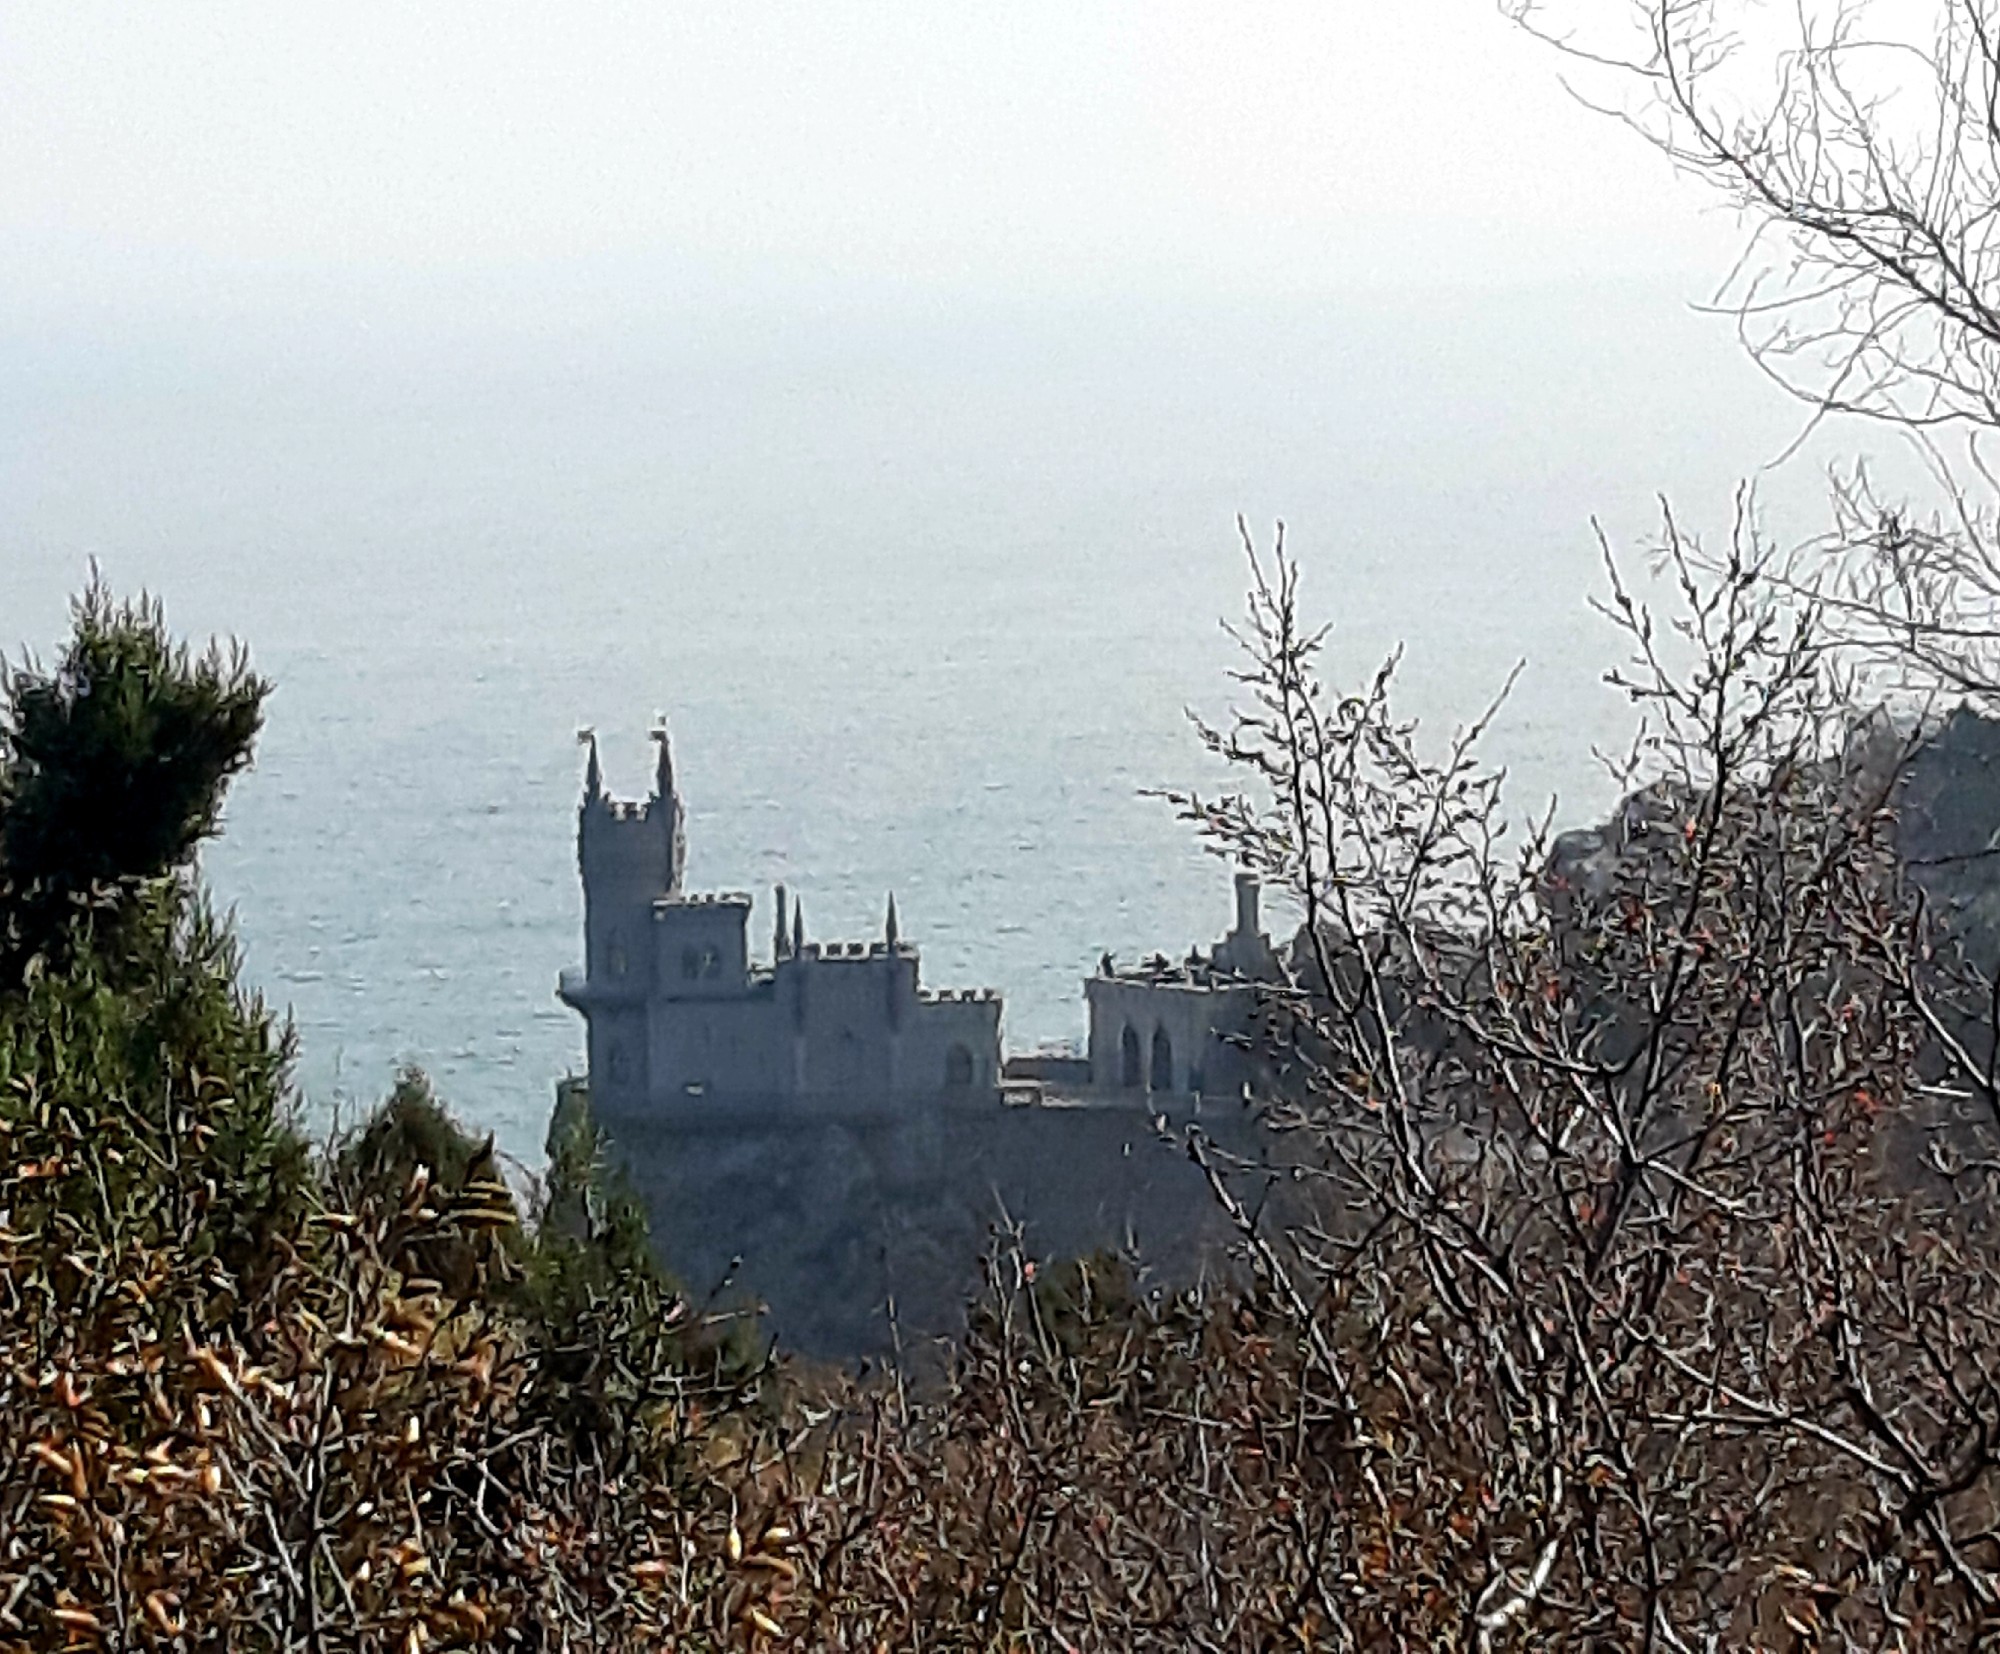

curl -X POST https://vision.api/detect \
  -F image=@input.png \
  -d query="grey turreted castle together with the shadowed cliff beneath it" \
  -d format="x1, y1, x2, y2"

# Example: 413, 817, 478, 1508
558, 728, 1280, 1358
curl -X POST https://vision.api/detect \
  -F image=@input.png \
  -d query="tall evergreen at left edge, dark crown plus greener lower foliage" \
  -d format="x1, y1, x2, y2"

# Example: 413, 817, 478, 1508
0, 584, 310, 1292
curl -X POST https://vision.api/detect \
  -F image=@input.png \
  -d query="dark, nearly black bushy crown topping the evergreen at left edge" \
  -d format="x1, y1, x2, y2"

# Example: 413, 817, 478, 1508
0, 580, 270, 980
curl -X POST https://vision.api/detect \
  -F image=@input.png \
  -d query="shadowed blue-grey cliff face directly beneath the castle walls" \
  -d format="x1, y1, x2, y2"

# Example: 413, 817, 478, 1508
584, 1098, 1256, 1360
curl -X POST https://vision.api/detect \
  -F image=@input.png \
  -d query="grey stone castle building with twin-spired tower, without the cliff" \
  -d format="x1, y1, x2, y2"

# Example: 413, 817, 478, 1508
560, 728, 1280, 1114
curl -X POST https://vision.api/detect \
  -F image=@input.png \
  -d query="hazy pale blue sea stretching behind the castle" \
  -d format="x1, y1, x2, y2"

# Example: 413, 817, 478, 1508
0, 288, 1814, 1162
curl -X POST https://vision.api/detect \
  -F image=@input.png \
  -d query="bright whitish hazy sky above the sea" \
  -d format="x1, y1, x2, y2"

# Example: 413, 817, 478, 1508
0, 0, 1732, 334
